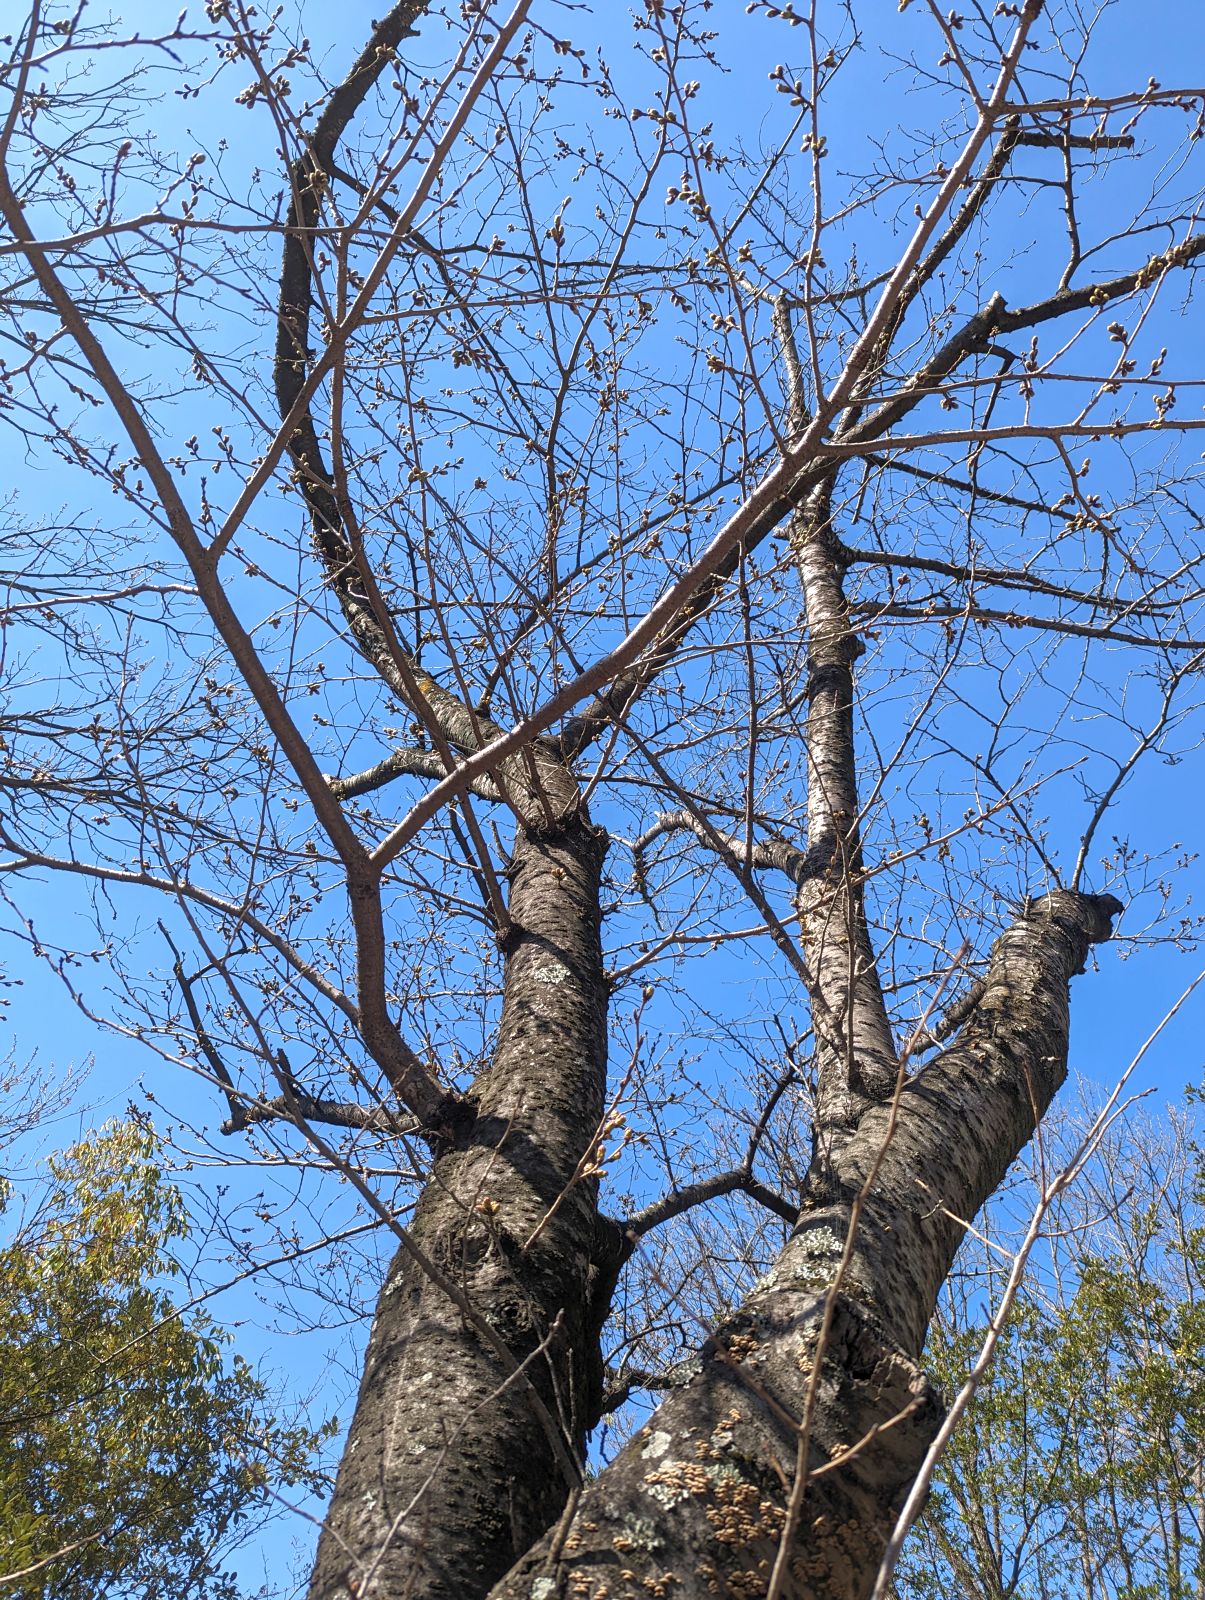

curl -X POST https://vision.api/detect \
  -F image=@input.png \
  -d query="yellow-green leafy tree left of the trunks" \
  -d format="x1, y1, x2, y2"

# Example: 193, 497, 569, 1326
0, 1123, 329, 1600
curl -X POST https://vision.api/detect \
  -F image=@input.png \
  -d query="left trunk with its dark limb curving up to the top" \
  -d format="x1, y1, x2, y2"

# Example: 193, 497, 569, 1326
275, 15, 626, 1600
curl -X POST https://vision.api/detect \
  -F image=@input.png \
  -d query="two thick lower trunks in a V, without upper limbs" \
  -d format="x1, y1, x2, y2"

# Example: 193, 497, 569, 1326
310, 883, 1120, 1600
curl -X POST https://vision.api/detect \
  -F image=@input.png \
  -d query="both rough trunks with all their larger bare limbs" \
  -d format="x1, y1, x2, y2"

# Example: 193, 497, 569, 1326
0, 0, 1177, 1600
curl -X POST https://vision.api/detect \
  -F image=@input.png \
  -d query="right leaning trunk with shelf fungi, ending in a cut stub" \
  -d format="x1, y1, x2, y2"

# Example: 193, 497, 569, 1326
491, 891, 1120, 1600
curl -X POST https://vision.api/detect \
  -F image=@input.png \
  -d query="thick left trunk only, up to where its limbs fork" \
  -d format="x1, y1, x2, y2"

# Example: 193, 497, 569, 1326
310, 819, 619, 1600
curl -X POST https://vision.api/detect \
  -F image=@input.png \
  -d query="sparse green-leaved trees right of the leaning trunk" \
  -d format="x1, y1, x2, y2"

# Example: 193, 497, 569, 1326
895, 1125, 1205, 1600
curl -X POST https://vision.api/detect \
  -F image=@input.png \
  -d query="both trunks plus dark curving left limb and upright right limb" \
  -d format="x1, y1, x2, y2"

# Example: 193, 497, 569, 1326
275, 15, 1112, 1600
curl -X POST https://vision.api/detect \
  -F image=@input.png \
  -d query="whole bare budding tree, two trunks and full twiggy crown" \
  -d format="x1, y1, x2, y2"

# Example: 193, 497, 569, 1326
0, 0, 1205, 1600
